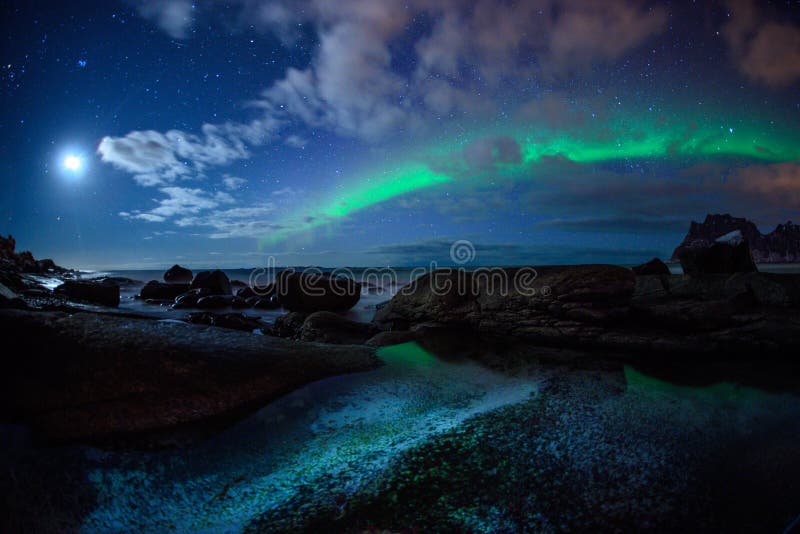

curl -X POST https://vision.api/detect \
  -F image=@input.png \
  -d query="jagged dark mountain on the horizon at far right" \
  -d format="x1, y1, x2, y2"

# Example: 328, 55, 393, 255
672, 213, 800, 263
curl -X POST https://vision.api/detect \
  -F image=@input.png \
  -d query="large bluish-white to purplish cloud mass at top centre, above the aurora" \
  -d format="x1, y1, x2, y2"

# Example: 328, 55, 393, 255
257, 0, 666, 141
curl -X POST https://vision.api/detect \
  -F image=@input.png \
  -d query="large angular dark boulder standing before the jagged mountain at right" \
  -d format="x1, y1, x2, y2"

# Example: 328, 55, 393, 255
680, 238, 758, 277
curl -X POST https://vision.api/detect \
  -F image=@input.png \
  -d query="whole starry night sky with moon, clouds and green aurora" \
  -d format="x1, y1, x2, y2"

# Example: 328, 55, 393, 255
0, 0, 800, 268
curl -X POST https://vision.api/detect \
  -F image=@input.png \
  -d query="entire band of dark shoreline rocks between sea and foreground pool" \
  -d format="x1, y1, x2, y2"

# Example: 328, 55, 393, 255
0, 232, 800, 442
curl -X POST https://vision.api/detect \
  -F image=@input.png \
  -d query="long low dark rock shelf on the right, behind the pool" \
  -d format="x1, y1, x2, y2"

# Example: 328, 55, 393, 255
375, 266, 800, 358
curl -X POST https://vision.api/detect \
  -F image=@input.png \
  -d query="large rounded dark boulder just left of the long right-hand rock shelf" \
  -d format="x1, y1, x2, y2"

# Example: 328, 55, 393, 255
276, 271, 361, 312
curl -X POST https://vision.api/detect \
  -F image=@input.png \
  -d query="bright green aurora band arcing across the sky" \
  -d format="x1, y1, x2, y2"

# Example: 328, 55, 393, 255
260, 115, 800, 248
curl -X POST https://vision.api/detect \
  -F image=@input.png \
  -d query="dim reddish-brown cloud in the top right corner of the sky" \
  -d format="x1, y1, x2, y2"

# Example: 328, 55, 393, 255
722, 0, 800, 87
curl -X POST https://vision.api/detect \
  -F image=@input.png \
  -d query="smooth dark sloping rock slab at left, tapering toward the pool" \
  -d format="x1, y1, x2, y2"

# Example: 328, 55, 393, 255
0, 310, 379, 441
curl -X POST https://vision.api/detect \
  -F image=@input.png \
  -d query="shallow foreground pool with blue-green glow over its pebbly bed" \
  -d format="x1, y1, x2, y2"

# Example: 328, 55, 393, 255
0, 343, 800, 532
